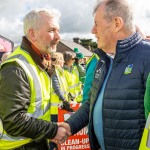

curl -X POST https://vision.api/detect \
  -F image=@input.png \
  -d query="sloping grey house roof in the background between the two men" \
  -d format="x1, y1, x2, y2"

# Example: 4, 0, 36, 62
60, 40, 93, 57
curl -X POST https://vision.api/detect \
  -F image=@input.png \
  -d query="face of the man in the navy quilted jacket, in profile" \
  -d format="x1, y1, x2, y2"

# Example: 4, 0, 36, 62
92, 5, 116, 53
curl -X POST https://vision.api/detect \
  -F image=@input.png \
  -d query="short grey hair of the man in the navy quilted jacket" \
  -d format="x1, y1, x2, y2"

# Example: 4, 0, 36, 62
93, 0, 135, 31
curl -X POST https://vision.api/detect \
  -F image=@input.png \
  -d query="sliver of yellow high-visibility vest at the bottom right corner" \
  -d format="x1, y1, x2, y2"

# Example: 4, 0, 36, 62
139, 114, 150, 150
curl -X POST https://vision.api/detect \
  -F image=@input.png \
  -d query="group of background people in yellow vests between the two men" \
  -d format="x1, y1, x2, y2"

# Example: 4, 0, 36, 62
50, 48, 85, 150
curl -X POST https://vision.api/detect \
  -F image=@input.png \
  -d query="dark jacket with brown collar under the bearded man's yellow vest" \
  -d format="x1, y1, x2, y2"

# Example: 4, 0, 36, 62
0, 38, 58, 150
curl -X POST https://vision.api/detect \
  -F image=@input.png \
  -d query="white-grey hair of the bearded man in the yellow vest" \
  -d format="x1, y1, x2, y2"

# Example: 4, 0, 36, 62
23, 8, 61, 37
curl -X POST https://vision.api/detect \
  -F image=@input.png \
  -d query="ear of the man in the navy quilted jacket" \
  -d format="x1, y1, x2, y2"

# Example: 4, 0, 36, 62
114, 17, 123, 32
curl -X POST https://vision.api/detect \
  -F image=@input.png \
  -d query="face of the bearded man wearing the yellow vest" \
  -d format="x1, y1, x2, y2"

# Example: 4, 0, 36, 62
31, 14, 60, 53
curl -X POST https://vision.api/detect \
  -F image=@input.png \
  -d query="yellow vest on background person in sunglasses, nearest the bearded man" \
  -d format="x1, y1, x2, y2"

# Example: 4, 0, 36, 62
51, 67, 69, 115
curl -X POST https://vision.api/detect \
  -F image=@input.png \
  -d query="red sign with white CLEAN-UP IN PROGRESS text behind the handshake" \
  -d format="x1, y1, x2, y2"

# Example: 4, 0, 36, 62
58, 103, 90, 150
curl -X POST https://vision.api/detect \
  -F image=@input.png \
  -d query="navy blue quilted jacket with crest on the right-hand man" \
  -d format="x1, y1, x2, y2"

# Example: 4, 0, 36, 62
67, 33, 150, 150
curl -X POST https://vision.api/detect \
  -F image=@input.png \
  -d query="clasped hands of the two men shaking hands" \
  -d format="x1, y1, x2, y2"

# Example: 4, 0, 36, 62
51, 122, 71, 144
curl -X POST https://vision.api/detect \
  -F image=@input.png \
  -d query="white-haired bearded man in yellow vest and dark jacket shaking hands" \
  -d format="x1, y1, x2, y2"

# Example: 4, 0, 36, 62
0, 8, 70, 150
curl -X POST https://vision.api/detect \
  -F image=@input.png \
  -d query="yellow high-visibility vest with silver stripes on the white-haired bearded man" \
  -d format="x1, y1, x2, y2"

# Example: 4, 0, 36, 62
0, 47, 51, 150
